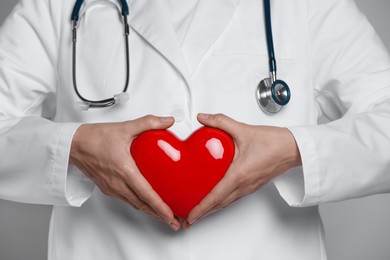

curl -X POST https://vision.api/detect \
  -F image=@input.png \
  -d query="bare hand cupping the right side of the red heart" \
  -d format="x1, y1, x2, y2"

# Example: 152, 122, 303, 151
183, 114, 301, 229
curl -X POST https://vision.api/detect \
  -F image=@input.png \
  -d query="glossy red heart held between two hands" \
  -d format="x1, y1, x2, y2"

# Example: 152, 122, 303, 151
130, 127, 234, 218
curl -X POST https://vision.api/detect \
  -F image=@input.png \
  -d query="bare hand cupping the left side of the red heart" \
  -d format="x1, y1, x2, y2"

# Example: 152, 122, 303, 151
70, 116, 181, 231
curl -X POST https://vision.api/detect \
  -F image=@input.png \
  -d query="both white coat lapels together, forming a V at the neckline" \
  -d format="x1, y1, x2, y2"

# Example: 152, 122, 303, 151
129, 0, 240, 79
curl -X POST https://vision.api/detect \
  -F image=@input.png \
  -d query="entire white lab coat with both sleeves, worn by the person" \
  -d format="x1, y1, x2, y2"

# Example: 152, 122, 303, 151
0, 0, 390, 260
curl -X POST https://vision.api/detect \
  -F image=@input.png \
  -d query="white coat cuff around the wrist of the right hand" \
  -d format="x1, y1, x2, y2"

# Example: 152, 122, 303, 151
274, 127, 321, 207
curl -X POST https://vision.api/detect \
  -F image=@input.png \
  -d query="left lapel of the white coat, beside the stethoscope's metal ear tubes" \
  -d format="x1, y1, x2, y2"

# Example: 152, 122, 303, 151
129, 0, 190, 83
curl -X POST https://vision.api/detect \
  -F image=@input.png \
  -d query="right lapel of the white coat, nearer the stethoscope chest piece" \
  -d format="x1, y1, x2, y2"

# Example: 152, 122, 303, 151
182, 0, 240, 73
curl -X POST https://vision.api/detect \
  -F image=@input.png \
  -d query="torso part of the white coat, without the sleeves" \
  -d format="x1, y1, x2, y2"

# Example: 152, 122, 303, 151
49, 0, 325, 260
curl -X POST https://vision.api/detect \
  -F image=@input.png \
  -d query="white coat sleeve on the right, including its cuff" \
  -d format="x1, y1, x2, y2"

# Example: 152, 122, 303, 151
275, 0, 390, 207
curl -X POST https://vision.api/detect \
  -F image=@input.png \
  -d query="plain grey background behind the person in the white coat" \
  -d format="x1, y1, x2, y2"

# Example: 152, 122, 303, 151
0, 0, 390, 260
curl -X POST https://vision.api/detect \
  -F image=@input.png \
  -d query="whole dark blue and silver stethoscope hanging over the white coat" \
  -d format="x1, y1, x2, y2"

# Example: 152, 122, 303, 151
72, 0, 291, 114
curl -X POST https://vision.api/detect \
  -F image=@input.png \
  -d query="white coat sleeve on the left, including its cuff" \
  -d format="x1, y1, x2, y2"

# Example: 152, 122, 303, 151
0, 0, 93, 206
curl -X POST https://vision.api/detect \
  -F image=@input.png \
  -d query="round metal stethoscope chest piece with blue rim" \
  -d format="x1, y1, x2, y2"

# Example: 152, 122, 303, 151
256, 78, 291, 114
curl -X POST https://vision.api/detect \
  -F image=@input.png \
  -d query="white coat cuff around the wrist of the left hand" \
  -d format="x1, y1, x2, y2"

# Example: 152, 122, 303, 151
51, 123, 95, 207
